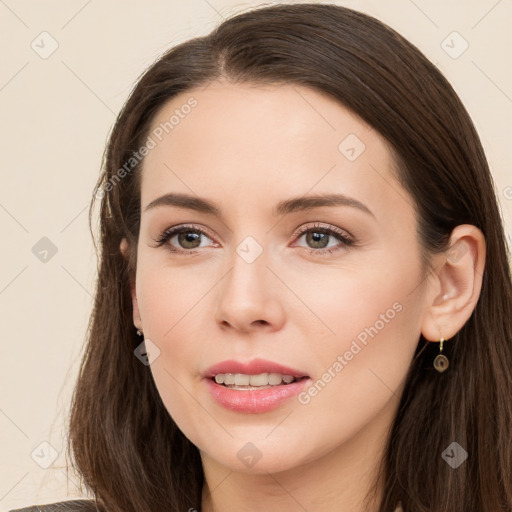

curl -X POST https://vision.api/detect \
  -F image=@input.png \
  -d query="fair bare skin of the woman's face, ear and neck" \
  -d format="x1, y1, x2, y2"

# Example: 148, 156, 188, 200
120, 81, 485, 512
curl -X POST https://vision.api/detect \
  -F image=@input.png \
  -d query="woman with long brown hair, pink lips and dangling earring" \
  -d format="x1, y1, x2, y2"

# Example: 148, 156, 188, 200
12, 4, 512, 512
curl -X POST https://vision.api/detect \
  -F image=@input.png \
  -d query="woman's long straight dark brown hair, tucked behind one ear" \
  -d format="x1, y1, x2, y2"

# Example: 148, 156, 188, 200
68, 4, 512, 512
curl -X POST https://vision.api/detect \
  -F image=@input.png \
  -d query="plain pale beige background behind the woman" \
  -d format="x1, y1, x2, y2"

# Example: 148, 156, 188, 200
0, 0, 512, 512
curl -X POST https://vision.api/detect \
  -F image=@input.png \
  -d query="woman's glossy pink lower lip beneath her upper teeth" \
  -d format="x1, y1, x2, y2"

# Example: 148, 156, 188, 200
205, 378, 311, 414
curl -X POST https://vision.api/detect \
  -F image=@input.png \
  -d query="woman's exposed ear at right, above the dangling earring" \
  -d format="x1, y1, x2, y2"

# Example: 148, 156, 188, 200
421, 224, 486, 341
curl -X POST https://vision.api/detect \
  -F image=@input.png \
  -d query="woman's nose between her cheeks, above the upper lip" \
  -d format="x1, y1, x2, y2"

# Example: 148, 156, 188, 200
215, 242, 285, 333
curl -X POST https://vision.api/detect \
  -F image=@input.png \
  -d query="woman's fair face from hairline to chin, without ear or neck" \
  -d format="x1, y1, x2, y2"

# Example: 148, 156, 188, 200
127, 82, 427, 473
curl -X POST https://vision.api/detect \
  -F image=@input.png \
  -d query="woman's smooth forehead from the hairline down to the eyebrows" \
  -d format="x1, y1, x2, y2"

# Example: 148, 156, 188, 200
141, 82, 404, 217
